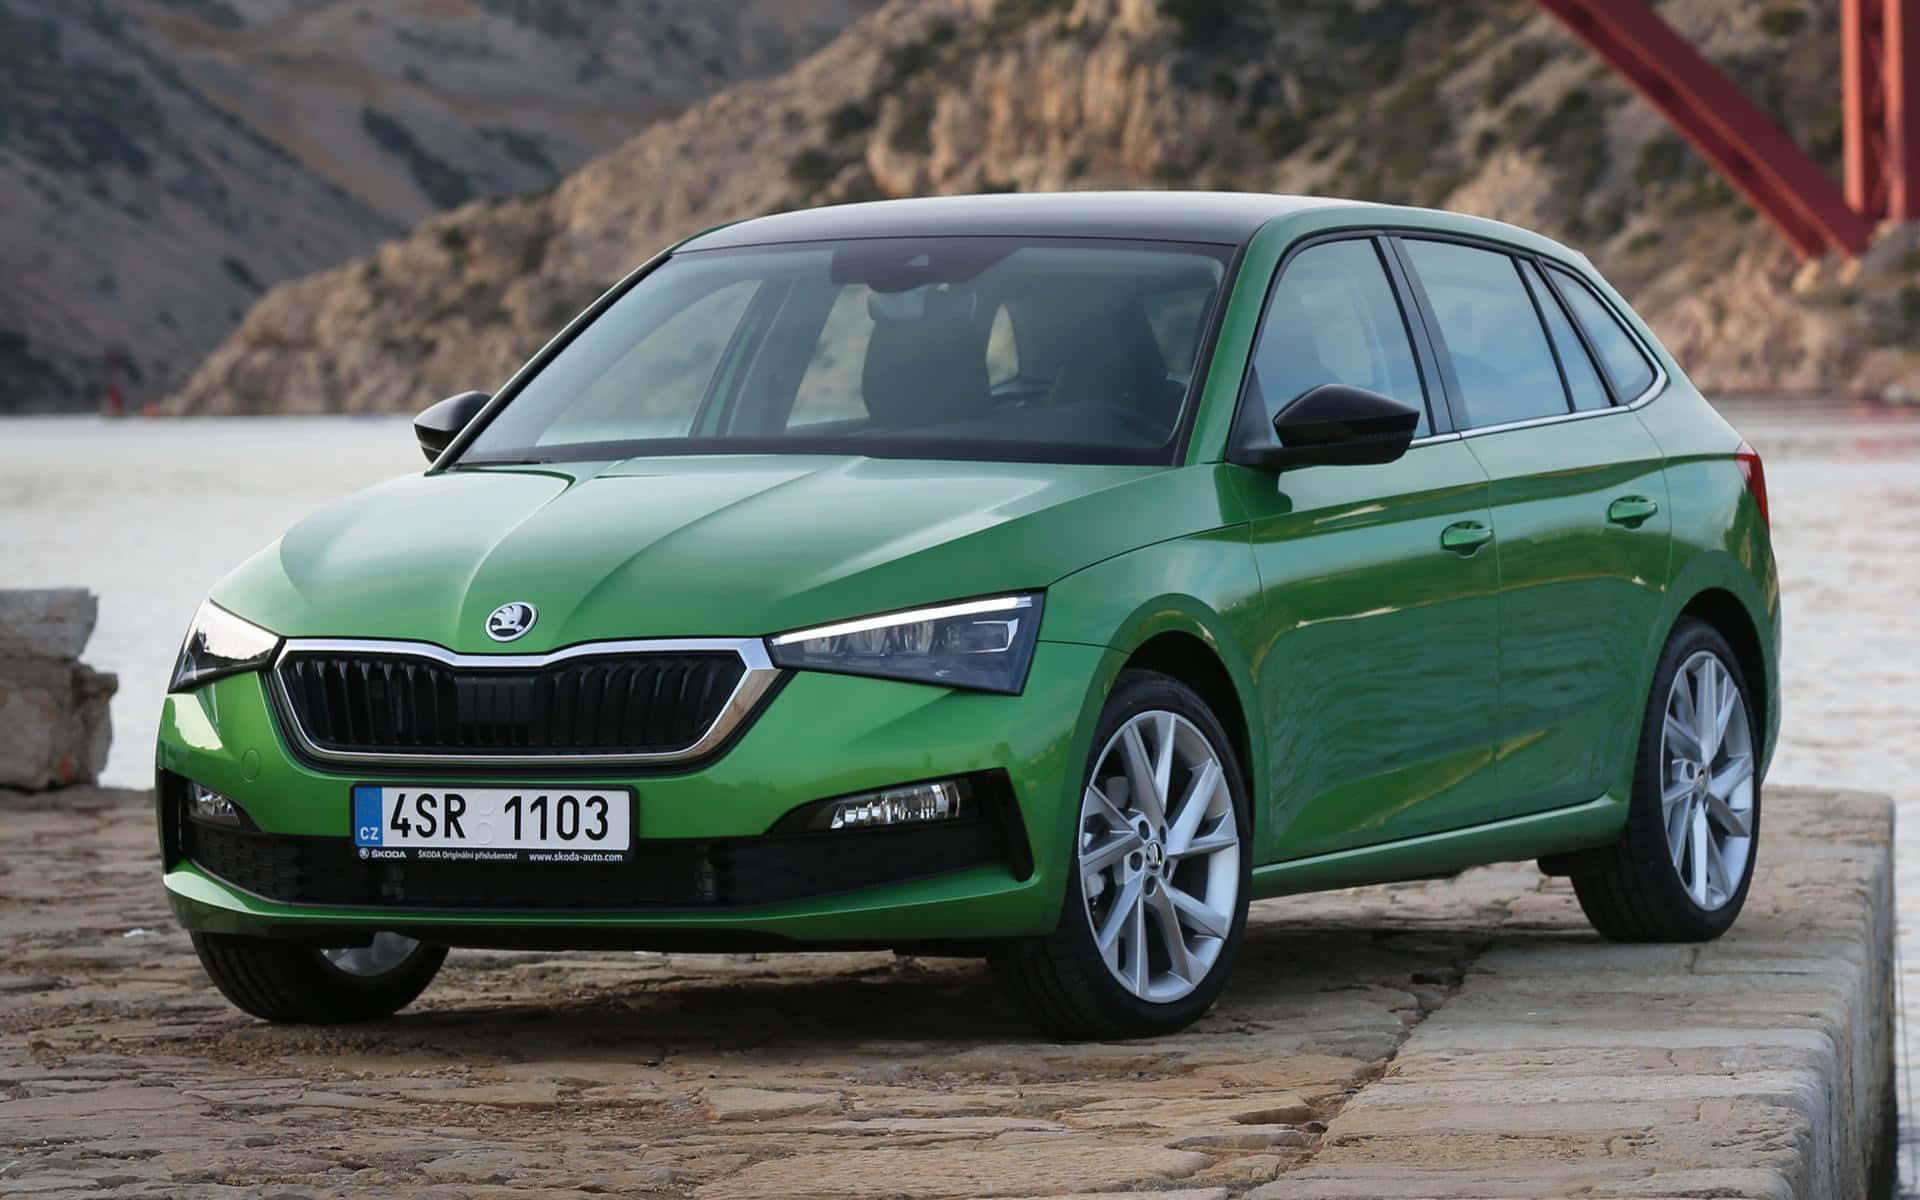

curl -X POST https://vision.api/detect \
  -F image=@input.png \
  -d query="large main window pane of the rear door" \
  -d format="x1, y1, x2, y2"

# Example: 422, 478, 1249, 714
1405, 240, 1569, 428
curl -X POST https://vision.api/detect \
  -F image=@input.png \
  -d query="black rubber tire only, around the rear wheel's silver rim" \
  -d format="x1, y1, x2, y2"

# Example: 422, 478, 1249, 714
1626, 618, 1763, 941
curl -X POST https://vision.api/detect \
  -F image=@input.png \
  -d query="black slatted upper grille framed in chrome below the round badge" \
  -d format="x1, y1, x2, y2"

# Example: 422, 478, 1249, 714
275, 649, 747, 758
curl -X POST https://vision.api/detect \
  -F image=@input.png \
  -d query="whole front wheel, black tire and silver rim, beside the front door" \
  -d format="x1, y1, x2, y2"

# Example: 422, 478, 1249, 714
995, 670, 1252, 1039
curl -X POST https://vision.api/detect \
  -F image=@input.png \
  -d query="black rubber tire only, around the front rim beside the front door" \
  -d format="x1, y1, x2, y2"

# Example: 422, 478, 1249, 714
1054, 670, 1254, 1037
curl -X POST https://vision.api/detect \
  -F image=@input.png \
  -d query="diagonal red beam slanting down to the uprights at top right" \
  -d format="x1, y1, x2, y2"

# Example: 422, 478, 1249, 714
1536, 0, 1873, 257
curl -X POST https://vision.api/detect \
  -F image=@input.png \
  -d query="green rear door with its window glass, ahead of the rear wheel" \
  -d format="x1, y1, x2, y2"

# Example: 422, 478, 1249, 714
1398, 236, 1670, 816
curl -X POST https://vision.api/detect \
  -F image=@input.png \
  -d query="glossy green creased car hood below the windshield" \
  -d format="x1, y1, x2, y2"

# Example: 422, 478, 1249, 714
213, 455, 1223, 653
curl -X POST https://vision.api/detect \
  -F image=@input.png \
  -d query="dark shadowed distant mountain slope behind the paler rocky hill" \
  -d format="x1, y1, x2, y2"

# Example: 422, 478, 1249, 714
0, 0, 877, 411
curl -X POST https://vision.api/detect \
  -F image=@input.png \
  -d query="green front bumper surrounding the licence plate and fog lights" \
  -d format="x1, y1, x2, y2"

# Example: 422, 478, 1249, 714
157, 641, 1119, 948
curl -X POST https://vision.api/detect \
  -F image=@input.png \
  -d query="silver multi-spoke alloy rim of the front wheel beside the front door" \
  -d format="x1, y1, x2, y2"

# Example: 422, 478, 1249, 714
1079, 710, 1240, 1004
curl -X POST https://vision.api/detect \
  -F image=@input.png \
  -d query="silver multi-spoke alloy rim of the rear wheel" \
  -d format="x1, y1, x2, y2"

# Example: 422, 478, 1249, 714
1661, 651, 1753, 912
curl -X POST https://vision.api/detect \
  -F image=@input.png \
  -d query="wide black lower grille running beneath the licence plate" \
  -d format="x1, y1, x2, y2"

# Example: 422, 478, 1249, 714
180, 814, 1023, 910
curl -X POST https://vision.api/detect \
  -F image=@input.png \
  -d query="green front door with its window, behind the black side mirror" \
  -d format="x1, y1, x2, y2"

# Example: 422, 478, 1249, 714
1231, 236, 1500, 858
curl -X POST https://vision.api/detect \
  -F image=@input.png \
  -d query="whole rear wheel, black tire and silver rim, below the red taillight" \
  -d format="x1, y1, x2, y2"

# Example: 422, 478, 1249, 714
1569, 618, 1764, 941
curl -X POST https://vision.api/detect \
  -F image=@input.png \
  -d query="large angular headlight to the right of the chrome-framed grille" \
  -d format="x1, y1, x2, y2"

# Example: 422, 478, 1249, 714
772, 591, 1041, 695
